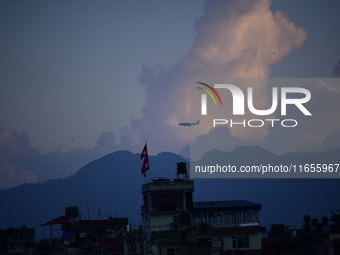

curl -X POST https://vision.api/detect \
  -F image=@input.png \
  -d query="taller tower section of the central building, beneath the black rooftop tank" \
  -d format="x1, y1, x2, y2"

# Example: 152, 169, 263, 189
141, 175, 194, 254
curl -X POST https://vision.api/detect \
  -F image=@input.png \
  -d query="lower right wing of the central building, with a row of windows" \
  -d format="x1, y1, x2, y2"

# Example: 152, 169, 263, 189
192, 200, 262, 254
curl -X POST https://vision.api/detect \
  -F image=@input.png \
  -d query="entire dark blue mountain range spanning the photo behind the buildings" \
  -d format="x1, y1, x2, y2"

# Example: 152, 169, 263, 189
0, 146, 340, 240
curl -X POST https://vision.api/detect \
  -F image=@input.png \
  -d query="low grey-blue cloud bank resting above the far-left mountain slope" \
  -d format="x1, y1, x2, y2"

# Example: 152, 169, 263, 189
0, 128, 123, 189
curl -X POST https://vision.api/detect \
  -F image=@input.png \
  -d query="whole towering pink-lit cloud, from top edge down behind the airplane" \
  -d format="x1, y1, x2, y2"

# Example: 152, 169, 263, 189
123, 0, 307, 153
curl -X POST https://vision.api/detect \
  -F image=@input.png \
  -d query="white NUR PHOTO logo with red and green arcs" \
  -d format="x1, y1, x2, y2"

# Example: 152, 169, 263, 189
197, 82, 312, 128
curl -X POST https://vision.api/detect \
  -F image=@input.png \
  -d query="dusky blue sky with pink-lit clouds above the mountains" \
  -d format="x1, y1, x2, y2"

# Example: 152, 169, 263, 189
0, 0, 340, 188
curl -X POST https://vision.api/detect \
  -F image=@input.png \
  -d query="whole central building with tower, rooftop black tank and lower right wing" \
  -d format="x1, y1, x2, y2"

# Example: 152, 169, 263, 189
141, 163, 262, 255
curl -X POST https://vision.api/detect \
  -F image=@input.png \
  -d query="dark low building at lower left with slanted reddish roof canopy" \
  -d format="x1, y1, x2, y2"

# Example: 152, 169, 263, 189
42, 207, 130, 254
